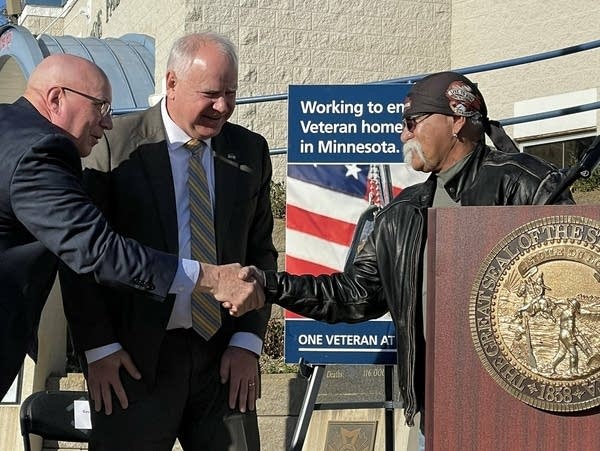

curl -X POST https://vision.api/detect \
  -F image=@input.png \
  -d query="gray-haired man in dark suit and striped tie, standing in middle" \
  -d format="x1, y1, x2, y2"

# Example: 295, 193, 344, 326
64, 33, 277, 451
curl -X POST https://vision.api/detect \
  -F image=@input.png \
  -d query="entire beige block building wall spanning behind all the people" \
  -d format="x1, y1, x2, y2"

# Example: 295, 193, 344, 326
22, 0, 600, 148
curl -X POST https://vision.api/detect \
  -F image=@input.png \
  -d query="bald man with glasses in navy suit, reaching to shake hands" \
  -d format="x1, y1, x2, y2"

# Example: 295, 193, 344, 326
0, 55, 262, 405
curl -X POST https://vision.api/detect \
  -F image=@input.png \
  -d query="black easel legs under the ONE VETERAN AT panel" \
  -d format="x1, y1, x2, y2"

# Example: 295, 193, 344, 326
289, 358, 400, 451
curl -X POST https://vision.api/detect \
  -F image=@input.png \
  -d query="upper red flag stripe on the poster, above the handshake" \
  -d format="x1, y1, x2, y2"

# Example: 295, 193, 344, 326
286, 205, 356, 246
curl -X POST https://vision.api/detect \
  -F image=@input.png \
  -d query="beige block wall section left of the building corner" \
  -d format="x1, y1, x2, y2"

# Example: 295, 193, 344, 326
22, 0, 452, 178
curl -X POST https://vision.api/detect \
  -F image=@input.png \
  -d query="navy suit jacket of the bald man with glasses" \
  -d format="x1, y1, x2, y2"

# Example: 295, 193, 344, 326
0, 98, 178, 397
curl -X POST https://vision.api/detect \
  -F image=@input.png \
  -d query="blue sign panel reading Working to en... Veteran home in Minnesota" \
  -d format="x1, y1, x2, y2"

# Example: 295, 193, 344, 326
288, 84, 410, 164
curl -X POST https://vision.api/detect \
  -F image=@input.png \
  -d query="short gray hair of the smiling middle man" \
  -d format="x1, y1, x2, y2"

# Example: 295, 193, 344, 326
167, 31, 238, 77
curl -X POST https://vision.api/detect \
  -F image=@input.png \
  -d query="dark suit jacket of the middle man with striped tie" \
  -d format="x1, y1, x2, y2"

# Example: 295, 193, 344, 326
63, 105, 277, 385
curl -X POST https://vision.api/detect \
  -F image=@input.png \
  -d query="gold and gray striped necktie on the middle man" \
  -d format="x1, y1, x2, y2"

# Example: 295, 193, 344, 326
184, 139, 221, 340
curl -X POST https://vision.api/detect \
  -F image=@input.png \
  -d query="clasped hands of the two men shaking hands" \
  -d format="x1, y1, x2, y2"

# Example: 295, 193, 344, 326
195, 263, 265, 316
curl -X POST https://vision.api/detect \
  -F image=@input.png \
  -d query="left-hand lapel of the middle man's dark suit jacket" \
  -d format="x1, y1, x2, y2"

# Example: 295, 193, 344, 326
139, 104, 179, 254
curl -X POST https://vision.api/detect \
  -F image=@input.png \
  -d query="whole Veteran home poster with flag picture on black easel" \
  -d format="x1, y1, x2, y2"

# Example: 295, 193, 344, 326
285, 83, 417, 451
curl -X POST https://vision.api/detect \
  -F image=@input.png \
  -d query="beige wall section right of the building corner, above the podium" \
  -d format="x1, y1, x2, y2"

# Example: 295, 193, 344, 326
451, 0, 600, 139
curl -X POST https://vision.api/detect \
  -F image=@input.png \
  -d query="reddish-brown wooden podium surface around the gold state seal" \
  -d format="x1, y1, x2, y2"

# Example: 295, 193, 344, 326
425, 206, 600, 451
